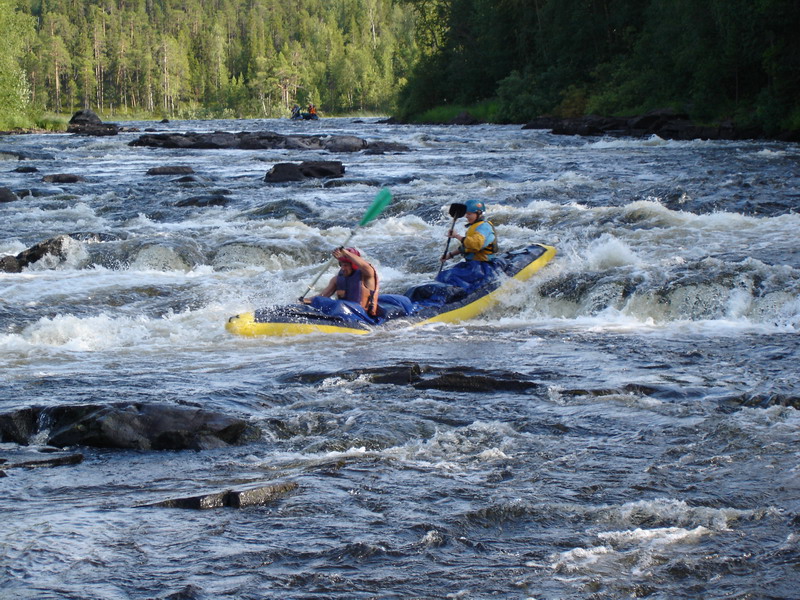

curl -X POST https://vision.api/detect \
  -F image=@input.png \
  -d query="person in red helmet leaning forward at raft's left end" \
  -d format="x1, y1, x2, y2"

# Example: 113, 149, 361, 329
303, 248, 380, 317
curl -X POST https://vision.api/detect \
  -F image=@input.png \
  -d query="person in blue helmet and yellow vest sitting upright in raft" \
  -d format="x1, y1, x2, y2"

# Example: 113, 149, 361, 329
436, 200, 497, 292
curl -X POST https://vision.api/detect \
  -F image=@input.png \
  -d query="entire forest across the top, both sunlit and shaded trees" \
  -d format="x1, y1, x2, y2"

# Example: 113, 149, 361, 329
0, 0, 800, 133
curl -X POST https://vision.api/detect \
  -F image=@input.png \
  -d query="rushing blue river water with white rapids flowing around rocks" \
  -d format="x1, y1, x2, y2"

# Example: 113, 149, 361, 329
0, 119, 800, 600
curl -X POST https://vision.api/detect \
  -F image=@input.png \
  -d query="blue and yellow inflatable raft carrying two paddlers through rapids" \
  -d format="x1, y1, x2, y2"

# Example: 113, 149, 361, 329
226, 244, 556, 337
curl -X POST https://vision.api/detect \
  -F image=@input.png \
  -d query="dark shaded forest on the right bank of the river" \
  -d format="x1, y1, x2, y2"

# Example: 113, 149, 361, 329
398, 0, 800, 133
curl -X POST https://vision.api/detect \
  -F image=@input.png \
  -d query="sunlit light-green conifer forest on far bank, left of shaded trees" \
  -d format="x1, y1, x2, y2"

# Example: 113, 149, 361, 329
17, 0, 418, 118
